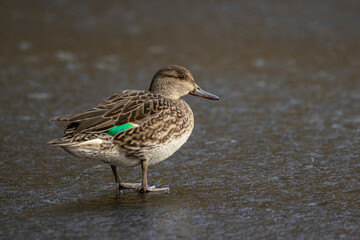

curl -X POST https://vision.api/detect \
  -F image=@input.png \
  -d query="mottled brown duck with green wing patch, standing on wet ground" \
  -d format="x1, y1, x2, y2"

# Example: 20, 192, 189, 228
49, 65, 219, 192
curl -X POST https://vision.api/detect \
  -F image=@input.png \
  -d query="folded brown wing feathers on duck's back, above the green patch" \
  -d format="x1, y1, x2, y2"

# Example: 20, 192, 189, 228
50, 90, 171, 135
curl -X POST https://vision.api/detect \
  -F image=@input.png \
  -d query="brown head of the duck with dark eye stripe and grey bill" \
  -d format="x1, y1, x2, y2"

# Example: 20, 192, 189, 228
149, 65, 219, 100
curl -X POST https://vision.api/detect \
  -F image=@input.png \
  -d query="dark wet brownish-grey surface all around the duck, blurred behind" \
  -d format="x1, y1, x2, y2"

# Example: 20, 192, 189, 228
0, 0, 360, 239
